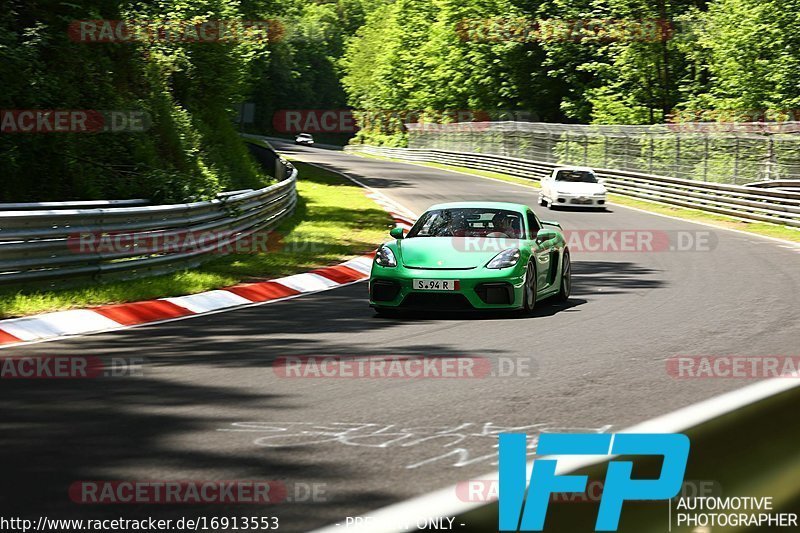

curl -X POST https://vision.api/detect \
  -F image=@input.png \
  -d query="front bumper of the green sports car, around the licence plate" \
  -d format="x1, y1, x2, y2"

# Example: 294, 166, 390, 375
369, 263, 525, 310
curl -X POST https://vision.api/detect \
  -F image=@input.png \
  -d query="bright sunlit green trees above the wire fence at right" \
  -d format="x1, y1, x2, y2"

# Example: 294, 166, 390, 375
340, 0, 800, 144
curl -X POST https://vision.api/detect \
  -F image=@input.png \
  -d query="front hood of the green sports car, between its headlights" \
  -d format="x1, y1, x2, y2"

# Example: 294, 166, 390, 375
397, 237, 519, 270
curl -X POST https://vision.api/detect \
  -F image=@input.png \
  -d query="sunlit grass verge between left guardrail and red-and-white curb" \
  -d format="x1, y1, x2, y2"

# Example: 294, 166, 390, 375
0, 162, 392, 318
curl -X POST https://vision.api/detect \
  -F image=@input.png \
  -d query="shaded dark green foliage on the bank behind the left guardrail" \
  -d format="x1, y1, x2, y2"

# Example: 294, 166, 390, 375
0, 0, 269, 201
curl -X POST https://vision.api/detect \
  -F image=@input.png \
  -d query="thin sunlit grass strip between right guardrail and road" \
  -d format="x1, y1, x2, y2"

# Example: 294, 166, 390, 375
357, 153, 800, 242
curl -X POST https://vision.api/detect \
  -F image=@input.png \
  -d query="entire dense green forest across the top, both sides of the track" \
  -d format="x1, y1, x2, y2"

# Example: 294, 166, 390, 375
0, 0, 800, 201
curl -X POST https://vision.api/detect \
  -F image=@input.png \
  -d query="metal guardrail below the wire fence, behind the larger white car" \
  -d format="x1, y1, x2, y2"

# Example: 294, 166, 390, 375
345, 145, 800, 227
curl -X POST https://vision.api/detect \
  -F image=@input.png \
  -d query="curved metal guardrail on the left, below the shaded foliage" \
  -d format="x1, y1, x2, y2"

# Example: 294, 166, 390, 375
0, 142, 297, 288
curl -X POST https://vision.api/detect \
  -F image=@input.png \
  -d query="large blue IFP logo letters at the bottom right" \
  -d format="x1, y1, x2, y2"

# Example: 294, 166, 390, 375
498, 433, 689, 531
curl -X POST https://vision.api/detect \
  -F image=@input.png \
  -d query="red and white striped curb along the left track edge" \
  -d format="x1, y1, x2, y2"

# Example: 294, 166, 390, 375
0, 186, 414, 350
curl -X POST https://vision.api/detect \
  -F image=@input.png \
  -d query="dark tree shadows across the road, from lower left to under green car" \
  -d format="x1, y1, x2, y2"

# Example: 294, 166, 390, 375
0, 261, 662, 530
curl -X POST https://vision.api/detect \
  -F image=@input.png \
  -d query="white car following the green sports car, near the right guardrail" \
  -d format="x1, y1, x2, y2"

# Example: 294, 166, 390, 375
539, 167, 608, 209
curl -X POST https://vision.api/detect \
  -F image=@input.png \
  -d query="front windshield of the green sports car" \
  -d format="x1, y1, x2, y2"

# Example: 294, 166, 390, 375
406, 207, 525, 239
